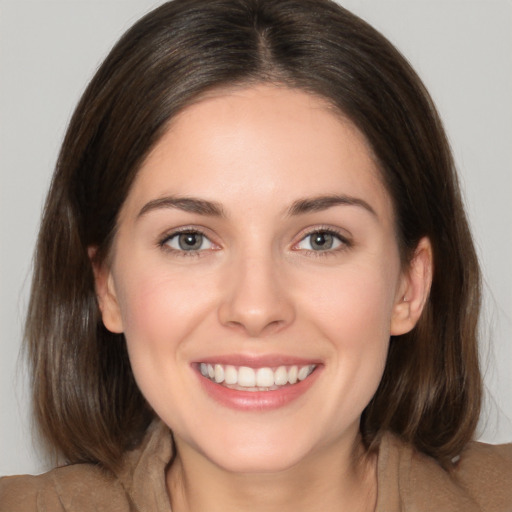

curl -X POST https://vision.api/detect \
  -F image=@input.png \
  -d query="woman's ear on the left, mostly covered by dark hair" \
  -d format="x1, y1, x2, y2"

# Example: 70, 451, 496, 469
87, 246, 124, 333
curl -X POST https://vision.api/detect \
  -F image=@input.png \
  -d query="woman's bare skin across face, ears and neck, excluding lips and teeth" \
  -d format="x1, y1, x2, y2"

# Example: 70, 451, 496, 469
95, 85, 432, 512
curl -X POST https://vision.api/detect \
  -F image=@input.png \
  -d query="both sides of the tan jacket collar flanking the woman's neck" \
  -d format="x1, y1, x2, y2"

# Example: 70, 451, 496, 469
117, 420, 480, 512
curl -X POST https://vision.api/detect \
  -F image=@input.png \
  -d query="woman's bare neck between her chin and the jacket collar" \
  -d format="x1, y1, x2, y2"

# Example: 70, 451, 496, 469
167, 437, 377, 512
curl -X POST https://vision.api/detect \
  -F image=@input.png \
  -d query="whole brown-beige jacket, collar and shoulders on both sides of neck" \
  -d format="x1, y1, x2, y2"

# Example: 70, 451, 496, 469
0, 422, 512, 512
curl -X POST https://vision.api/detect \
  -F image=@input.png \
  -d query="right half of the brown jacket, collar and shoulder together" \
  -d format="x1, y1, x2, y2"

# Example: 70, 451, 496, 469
377, 434, 512, 512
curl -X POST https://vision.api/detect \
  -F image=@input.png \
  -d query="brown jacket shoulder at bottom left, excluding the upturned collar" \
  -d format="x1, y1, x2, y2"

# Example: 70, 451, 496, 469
0, 464, 130, 512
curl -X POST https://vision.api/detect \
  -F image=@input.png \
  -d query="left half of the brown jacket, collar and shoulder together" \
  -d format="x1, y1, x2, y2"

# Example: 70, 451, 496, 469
0, 420, 173, 512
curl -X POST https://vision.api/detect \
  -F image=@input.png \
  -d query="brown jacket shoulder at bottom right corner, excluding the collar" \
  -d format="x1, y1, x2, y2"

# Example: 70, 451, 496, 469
453, 442, 512, 512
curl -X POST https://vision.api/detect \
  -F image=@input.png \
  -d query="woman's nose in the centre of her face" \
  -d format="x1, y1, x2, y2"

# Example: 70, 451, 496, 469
218, 257, 295, 337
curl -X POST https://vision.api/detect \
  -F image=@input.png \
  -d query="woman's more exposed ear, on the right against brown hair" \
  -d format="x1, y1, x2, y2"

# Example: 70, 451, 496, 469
391, 237, 433, 336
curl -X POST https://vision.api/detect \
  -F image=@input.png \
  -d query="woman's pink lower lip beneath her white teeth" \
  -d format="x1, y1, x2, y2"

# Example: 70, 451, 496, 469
197, 367, 320, 411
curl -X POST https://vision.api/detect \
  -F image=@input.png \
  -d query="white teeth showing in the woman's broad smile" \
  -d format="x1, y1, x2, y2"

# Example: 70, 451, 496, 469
199, 363, 317, 391
